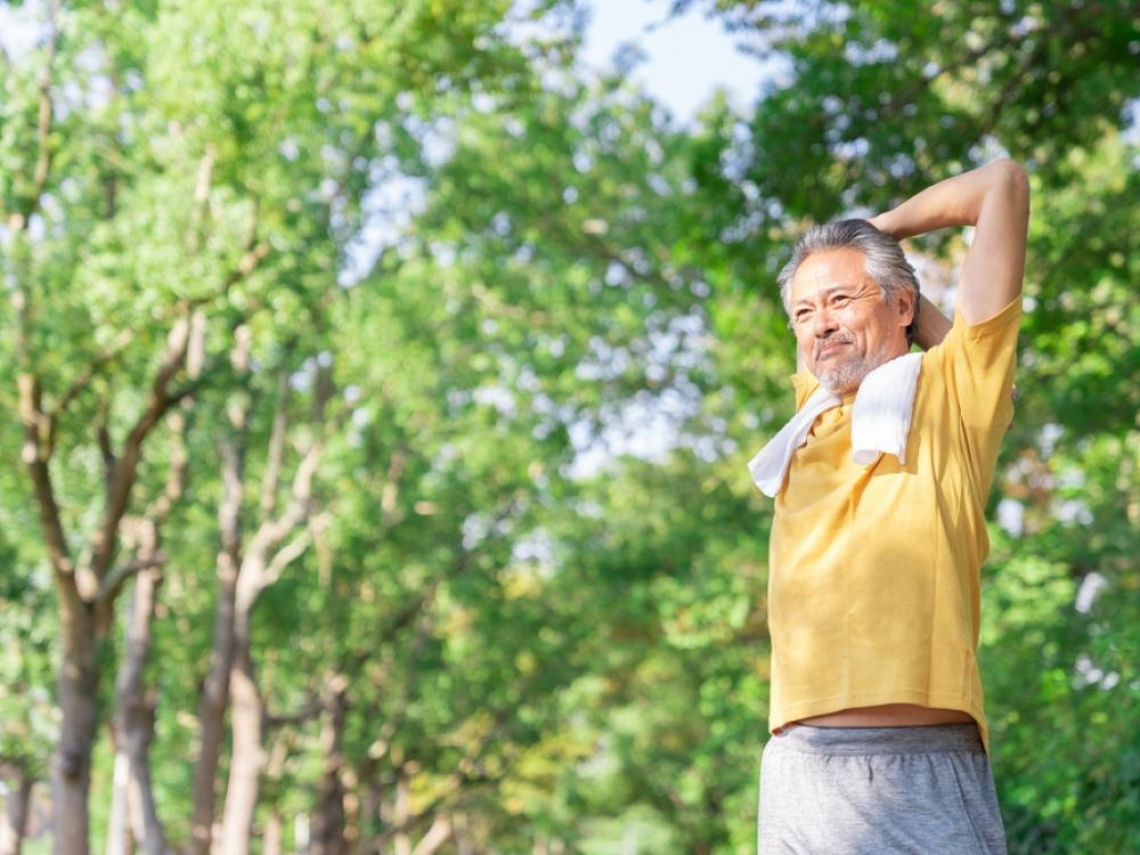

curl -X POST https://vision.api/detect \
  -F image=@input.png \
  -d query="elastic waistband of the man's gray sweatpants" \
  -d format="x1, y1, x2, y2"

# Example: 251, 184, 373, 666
771, 724, 985, 755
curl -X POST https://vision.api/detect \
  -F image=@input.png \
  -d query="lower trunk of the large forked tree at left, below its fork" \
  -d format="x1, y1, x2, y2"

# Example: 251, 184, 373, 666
51, 588, 99, 855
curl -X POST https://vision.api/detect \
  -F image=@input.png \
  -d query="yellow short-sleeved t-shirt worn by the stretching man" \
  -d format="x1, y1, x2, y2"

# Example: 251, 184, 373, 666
768, 298, 1021, 751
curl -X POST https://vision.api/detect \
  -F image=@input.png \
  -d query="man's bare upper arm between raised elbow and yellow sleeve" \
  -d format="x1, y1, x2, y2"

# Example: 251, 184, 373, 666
958, 161, 1029, 325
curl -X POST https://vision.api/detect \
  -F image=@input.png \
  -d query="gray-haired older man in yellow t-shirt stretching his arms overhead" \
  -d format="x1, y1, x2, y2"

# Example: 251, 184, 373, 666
754, 161, 1028, 855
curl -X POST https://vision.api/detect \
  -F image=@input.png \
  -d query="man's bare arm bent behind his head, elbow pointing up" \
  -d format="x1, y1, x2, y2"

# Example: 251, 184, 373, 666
871, 160, 1029, 326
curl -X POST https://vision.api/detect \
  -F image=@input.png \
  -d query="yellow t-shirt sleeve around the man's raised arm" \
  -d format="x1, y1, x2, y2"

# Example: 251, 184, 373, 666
923, 294, 1021, 489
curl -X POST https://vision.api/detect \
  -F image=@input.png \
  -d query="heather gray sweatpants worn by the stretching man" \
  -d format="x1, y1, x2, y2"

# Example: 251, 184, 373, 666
759, 724, 1005, 855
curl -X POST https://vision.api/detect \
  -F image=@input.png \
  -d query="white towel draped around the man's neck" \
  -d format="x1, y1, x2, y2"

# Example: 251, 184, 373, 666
748, 353, 922, 497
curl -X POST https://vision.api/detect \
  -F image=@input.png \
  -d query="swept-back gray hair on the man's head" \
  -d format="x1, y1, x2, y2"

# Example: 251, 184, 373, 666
776, 220, 920, 341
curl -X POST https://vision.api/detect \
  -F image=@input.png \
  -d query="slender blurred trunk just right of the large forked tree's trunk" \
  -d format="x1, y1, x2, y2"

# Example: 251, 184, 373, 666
107, 568, 165, 855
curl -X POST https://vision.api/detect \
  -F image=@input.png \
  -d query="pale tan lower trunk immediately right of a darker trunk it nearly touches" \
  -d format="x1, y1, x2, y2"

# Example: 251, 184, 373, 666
221, 611, 264, 855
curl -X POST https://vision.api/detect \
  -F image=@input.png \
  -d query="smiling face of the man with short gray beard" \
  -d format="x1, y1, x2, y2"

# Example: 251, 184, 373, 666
790, 249, 914, 394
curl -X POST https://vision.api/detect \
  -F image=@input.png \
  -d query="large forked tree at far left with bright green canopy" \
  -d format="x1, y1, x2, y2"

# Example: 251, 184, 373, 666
2, 2, 579, 852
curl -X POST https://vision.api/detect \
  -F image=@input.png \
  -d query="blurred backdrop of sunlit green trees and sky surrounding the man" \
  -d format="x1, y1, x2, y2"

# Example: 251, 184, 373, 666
0, 0, 1140, 855
